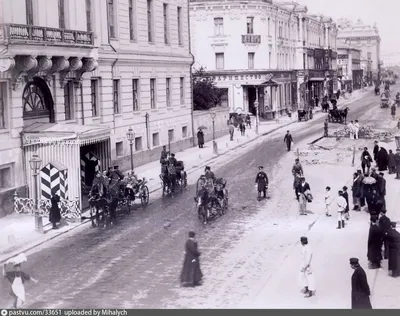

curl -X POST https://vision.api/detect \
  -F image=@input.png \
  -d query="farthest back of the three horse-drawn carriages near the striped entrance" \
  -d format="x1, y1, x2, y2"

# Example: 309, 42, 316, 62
160, 161, 187, 196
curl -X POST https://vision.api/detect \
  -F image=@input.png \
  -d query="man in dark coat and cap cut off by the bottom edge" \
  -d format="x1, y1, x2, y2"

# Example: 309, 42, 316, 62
350, 258, 372, 309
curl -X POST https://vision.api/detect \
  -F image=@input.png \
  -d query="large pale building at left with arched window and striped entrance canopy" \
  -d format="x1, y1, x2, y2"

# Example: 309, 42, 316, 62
0, 0, 193, 215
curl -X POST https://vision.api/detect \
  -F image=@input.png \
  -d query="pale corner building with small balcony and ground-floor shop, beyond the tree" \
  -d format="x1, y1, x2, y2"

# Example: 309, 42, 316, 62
190, 0, 336, 118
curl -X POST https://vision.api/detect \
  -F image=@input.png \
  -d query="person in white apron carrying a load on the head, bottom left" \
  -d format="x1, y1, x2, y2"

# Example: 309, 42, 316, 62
3, 263, 38, 309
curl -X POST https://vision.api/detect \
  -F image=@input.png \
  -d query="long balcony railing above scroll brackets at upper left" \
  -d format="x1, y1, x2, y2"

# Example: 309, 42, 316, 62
0, 24, 94, 46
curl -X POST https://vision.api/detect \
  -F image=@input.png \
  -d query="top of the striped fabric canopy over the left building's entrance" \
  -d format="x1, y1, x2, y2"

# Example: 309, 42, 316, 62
22, 123, 111, 146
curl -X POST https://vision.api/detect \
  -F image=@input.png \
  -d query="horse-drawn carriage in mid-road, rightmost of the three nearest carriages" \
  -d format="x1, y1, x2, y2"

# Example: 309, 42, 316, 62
194, 175, 228, 224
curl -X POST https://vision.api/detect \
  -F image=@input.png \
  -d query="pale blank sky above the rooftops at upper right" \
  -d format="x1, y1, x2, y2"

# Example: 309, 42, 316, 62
296, 0, 400, 54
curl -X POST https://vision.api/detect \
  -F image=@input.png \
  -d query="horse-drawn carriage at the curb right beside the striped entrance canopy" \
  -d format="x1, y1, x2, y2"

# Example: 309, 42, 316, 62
86, 178, 149, 227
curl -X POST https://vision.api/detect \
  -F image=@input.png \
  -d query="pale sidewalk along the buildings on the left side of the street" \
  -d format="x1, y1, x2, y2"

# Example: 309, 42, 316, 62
0, 87, 364, 262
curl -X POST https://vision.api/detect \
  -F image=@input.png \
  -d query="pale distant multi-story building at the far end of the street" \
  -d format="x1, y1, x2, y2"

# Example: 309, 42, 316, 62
338, 19, 381, 82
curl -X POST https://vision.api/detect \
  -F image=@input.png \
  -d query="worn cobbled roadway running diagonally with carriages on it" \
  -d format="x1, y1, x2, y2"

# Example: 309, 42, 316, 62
0, 86, 394, 308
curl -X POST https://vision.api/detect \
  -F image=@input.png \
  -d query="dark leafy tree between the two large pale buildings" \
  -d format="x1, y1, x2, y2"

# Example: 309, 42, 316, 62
193, 67, 222, 111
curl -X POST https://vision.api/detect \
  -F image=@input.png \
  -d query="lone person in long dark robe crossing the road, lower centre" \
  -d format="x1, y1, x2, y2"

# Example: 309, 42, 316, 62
181, 231, 203, 287
